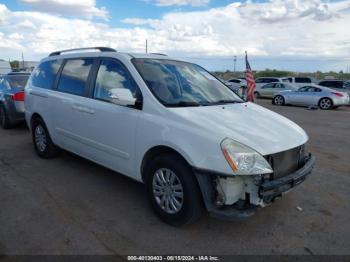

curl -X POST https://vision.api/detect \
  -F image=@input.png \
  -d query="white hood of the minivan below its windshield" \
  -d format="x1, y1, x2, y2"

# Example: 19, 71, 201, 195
169, 103, 308, 155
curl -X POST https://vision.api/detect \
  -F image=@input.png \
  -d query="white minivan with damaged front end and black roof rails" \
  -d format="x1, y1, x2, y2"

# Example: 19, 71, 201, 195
25, 47, 315, 226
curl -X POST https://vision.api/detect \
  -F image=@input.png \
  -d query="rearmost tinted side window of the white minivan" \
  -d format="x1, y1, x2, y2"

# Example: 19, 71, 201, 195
32, 60, 62, 89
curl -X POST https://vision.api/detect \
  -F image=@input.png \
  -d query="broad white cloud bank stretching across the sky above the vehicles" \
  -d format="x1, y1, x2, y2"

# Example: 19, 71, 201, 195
0, 0, 350, 71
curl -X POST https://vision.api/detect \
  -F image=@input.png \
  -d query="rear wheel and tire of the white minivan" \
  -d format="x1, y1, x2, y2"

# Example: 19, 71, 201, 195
32, 118, 58, 159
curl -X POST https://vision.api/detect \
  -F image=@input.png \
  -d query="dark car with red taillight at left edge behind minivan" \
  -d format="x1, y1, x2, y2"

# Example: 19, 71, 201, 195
0, 73, 30, 129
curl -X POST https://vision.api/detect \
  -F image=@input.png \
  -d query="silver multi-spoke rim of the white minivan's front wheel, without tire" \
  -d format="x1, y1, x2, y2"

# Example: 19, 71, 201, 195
152, 168, 184, 214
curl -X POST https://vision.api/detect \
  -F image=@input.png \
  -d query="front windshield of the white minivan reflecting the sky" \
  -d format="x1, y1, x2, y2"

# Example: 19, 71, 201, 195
132, 58, 243, 107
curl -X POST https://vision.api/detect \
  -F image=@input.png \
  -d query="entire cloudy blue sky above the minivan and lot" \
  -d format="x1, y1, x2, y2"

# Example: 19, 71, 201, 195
0, 0, 350, 72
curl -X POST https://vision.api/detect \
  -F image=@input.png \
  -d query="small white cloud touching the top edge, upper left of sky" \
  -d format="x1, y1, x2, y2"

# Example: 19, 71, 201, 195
21, 0, 108, 19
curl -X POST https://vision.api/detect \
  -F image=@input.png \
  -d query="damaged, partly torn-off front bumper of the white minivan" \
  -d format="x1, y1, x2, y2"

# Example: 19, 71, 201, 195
194, 155, 315, 219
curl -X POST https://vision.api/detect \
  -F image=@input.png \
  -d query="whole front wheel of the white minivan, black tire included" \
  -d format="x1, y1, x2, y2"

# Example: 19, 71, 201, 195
145, 153, 203, 226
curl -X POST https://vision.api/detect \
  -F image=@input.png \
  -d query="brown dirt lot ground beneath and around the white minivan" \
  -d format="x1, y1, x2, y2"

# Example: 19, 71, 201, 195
0, 100, 350, 255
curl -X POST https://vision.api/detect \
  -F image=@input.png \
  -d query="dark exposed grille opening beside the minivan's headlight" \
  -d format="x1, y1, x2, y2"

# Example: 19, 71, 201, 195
265, 145, 305, 179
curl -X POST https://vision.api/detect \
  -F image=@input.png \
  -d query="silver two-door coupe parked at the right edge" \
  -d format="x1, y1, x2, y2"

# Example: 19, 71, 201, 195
272, 85, 349, 110
